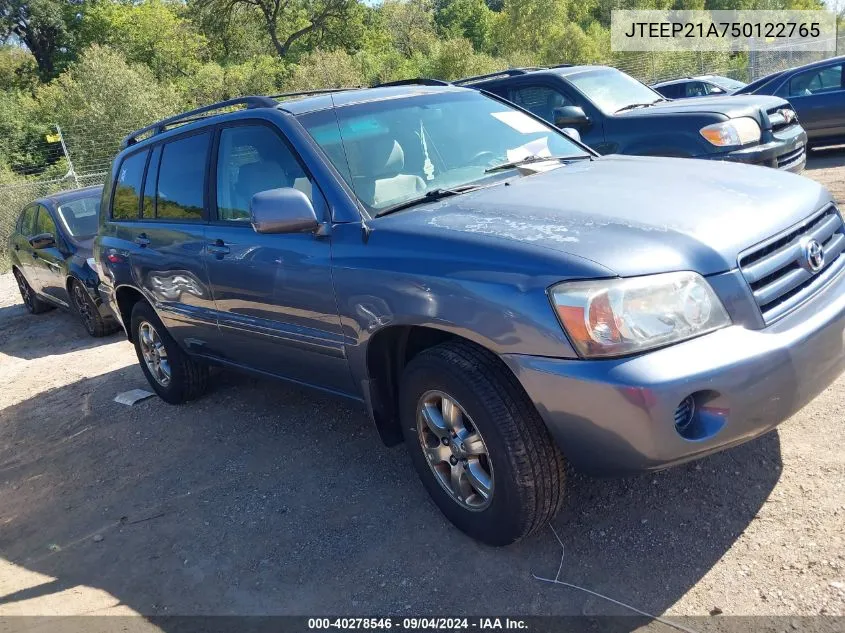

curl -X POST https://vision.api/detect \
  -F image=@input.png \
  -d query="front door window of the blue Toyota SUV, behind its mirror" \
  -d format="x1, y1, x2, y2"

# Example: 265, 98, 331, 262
217, 125, 312, 222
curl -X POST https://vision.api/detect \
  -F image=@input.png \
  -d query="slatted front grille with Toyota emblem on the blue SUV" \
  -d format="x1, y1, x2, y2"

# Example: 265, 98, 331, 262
739, 204, 845, 323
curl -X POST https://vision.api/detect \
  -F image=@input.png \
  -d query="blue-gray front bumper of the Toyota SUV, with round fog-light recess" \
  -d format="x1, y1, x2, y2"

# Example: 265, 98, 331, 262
504, 262, 845, 474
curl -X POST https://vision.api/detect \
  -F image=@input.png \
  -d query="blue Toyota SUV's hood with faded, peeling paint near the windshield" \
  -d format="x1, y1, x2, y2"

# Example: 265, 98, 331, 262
388, 155, 830, 276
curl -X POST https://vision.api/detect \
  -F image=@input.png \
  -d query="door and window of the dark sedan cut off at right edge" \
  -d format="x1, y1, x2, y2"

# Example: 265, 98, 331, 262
778, 62, 845, 141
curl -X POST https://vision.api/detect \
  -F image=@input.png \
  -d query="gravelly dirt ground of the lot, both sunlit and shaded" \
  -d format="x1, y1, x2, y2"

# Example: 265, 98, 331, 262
0, 150, 845, 631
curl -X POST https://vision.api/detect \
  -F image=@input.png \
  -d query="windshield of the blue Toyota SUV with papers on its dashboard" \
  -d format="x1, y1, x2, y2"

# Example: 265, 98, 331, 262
299, 91, 586, 211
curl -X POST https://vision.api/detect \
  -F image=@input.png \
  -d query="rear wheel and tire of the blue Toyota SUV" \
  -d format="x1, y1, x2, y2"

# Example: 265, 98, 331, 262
131, 301, 208, 404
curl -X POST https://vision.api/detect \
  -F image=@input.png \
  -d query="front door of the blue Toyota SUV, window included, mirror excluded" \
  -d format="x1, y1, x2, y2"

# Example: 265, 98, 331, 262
206, 121, 354, 394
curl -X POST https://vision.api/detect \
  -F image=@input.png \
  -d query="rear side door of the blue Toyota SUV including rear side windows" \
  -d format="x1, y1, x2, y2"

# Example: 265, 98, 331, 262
111, 130, 219, 353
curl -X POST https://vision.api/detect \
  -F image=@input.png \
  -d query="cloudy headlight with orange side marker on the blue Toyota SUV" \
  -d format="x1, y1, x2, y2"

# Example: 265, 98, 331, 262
551, 272, 731, 357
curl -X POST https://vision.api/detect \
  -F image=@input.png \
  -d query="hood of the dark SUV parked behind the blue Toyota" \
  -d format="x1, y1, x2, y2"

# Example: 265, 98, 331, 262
616, 95, 789, 127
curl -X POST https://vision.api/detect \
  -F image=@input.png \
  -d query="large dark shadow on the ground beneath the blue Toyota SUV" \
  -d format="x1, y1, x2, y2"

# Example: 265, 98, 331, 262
0, 360, 781, 627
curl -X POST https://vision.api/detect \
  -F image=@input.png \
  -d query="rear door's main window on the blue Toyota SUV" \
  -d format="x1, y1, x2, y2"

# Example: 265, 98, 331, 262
156, 133, 211, 220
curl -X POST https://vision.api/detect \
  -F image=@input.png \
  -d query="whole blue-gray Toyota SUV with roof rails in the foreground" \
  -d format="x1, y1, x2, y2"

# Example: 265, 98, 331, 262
95, 85, 845, 545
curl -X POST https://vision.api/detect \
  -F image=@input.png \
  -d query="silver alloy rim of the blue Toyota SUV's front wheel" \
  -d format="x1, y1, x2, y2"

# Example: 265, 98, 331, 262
417, 391, 493, 511
